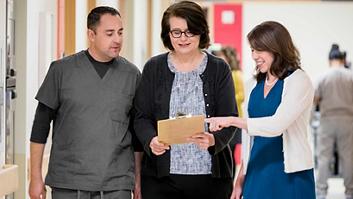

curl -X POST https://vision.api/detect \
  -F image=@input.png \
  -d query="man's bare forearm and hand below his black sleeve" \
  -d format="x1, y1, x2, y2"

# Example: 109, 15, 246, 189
29, 142, 46, 199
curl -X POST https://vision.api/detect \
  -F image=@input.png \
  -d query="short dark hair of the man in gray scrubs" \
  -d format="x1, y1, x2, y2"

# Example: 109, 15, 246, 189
87, 6, 120, 30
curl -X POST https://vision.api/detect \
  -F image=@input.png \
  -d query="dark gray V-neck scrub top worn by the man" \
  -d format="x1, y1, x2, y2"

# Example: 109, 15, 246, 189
36, 51, 140, 191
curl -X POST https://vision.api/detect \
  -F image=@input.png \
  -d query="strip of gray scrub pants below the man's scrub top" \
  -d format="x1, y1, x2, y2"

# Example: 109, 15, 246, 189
52, 187, 131, 199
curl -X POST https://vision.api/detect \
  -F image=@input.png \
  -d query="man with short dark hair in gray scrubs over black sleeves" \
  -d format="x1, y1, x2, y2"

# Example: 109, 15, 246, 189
29, 7, 140, 199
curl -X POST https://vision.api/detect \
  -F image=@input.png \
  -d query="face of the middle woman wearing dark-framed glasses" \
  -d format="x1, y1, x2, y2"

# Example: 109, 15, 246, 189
169, 17, 200, 54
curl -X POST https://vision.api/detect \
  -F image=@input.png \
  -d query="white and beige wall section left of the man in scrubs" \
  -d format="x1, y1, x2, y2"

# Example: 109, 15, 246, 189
14, 0, 57, 199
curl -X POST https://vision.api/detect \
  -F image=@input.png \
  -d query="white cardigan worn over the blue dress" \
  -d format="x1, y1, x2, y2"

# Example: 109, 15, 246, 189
242, 69, 314, 174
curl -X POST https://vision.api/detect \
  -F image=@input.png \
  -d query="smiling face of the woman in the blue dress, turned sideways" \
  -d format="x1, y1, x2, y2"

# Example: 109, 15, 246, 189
251, 49, 274, 73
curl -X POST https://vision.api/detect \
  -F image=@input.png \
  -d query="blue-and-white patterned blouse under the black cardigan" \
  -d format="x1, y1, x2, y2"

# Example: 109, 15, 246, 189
168, 53, 212, 175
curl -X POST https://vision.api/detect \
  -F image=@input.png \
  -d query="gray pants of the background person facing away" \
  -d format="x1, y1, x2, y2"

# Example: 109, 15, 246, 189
316, 118, 353, 196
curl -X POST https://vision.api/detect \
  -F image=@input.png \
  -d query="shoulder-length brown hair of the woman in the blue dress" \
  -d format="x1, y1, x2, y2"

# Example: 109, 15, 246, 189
247, 21, 301, 81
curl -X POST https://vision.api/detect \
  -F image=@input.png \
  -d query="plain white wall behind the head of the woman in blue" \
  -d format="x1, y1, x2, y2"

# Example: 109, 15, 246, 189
243, 1, 353, 80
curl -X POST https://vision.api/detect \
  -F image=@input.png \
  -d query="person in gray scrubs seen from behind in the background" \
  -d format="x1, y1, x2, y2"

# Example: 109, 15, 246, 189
315, 44, 353, 199
